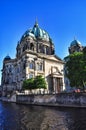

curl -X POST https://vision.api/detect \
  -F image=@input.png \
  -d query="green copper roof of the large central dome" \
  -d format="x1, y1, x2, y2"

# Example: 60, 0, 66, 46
21, 22, 51, 41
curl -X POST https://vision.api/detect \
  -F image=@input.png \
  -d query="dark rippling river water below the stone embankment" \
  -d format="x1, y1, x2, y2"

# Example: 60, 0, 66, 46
0, 102, 86, 130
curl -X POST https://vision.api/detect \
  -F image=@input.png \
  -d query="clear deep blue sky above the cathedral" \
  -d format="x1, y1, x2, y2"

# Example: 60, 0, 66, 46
0, 0, 86, 84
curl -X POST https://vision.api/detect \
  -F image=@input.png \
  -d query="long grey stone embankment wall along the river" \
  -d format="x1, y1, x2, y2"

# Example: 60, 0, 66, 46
16, 93, 86, 107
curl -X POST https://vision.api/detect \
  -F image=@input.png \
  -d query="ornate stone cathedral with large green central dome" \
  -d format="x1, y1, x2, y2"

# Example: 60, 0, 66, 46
1, 21, 64, 93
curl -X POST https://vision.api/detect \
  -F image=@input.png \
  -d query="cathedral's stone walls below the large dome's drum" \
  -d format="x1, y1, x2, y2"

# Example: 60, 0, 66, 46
3, 54, 64, 93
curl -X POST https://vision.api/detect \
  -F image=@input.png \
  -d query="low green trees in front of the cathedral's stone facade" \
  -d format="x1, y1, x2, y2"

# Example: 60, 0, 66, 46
22, 75, 47, 90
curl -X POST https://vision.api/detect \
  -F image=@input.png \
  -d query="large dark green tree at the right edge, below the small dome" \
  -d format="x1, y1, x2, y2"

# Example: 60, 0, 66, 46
65, 52, 86, 88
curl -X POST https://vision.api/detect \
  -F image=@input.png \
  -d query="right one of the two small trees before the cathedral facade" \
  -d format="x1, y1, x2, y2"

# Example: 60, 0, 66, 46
34, 75, 47, 89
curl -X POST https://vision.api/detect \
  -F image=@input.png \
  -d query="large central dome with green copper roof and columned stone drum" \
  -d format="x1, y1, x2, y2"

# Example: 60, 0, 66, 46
16, 22, 55, 57
